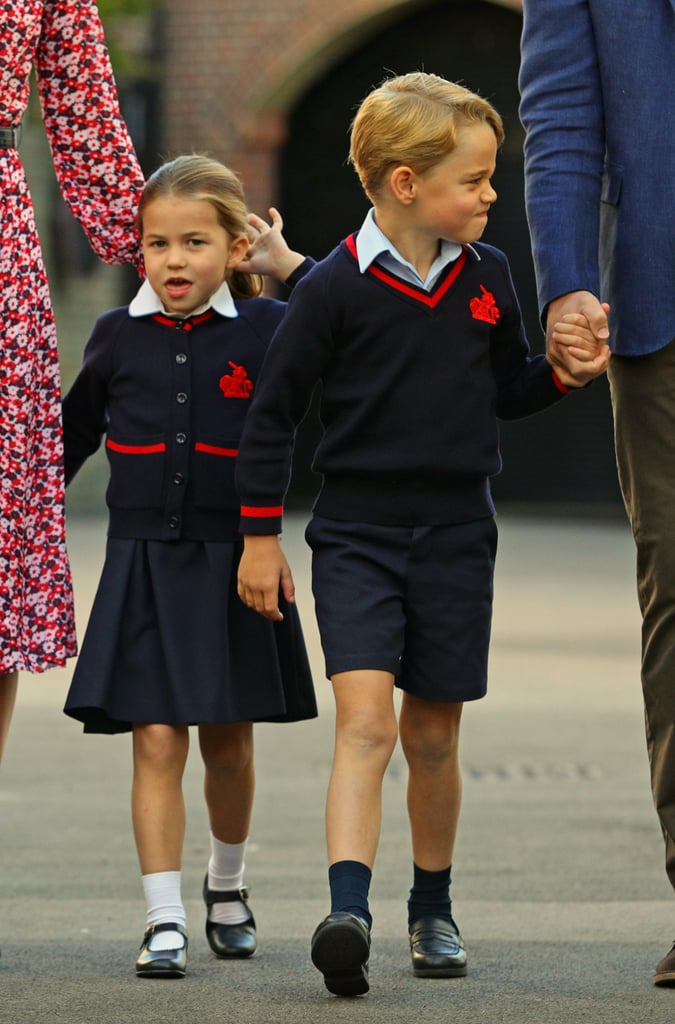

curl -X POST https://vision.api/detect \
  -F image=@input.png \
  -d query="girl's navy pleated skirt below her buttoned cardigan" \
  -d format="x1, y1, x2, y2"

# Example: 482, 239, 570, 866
64, 538, 317, 733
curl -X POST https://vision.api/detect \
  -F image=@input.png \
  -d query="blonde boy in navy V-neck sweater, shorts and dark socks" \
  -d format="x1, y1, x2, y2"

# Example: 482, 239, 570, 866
237, 73, 608, 995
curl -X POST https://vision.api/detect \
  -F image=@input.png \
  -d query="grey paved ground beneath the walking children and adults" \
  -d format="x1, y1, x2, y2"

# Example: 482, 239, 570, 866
0, 517, 675, 1024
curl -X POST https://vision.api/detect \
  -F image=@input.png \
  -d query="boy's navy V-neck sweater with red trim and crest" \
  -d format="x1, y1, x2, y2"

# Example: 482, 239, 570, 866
236, 236, 567, 534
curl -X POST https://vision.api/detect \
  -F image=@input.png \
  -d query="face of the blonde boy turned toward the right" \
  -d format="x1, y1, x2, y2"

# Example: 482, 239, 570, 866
415, 124, 497, 243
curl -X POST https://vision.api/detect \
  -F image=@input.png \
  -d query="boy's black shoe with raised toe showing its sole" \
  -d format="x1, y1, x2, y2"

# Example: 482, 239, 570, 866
311, 910, 371, 995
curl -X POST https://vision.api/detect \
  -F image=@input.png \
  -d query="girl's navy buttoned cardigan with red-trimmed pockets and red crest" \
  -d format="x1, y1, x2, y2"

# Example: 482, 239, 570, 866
64, 292, 309, 541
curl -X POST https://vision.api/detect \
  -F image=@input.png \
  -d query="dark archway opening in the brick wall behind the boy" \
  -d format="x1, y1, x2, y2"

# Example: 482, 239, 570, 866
280, 0, 620, 508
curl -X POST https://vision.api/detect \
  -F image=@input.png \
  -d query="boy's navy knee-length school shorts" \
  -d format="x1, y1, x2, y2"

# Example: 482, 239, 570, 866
305, 516, 497, 702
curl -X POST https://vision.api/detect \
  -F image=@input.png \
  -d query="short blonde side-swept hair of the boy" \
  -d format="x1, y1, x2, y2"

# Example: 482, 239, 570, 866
349, 71, 504, 201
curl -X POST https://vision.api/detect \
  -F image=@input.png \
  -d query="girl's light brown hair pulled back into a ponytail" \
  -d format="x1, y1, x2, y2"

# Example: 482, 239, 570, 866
136, 154, 262, 299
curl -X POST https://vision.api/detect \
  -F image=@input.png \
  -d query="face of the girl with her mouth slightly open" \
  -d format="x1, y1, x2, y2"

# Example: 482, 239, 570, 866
142, 196, 248, 316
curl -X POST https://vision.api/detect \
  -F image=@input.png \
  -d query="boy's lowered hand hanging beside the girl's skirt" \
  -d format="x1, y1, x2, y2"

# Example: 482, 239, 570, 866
237, 535, 295, 623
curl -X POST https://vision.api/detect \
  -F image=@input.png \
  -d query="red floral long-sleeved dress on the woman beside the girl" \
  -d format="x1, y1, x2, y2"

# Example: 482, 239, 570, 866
0, 0, 142, 673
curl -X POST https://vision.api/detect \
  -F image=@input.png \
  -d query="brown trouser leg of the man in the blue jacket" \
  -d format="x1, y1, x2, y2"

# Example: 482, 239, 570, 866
609, 341, 675, 889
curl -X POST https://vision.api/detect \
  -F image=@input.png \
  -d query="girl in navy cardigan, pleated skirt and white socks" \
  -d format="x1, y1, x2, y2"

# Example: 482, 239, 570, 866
64, 156, 317, 978
